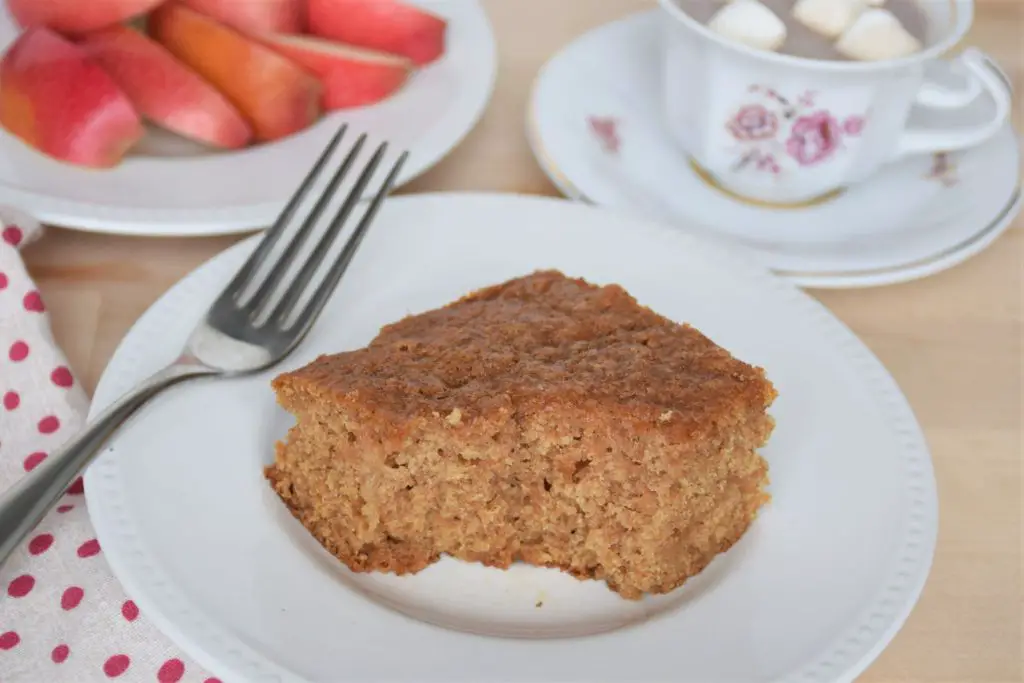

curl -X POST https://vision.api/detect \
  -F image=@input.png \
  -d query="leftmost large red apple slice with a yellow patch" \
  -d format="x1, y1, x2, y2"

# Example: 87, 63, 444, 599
0, 27, 143, 168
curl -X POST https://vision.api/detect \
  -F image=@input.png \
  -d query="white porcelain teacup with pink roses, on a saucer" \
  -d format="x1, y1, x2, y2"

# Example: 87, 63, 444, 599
660, 0, 1012, 205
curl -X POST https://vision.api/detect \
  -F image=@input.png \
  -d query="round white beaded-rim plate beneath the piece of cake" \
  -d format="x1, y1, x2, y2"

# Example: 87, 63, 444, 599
86, 195, 937, 683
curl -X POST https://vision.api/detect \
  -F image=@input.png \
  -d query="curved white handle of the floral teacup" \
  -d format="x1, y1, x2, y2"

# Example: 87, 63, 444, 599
895, 48, 1013, 159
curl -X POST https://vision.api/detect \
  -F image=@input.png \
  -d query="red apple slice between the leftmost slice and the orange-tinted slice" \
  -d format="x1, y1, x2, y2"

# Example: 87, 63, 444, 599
81, 27, 252, 150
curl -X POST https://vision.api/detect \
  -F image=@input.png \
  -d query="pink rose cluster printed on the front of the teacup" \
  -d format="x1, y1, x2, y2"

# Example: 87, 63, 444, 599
725, 85, 865, 176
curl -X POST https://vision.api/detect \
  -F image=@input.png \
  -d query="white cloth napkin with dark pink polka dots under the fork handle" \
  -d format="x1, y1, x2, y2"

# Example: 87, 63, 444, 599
0, 208, 219, 683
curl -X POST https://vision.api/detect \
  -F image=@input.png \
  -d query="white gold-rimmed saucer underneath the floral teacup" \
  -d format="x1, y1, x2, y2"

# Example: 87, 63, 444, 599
527, 10, 1022, 288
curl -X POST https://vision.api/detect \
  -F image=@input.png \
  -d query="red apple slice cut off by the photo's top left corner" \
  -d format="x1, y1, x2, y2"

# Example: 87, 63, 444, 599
7, 0, 164, 34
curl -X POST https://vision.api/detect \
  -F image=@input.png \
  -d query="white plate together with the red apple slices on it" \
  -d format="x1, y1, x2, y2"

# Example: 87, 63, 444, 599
0, 0, 497, 236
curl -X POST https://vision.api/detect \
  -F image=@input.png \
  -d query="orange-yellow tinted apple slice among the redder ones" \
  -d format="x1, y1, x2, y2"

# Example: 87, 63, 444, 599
148, 3, 323, 141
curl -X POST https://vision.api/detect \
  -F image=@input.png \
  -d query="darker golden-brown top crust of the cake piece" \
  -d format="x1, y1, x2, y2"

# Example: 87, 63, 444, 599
273, 270, 775, 435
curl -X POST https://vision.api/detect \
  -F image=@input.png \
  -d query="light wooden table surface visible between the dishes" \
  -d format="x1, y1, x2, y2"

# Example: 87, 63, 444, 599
18, 0, 1024, 683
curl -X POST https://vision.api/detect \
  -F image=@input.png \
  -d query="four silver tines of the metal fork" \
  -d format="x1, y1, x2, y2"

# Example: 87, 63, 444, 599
225, 125, 409, 334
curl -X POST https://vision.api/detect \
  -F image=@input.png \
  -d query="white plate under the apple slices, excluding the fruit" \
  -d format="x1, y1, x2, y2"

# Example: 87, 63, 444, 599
0, 0, 498, 236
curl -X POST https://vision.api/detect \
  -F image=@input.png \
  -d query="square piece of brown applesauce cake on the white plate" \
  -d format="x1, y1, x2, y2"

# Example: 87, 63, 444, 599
266, 271, 776, 599
